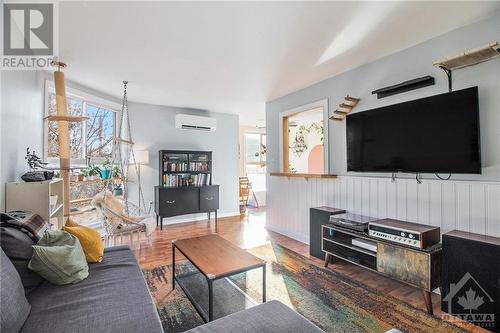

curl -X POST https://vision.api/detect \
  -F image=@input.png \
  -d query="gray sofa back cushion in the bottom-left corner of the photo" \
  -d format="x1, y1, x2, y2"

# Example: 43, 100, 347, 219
0, 249, 30, 332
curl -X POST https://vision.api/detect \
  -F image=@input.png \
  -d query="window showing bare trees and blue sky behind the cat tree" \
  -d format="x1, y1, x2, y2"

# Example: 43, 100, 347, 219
45, 82, 119, 164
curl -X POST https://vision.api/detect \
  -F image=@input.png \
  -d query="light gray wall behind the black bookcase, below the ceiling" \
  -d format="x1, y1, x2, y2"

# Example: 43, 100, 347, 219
129, 103, 239, 222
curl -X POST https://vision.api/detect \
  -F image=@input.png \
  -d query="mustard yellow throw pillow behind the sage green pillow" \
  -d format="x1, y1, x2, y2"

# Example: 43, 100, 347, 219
63, 222, 104, 263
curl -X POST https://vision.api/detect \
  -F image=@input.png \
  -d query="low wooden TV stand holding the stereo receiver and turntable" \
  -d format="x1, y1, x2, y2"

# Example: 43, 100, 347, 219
321, 224, 442, 315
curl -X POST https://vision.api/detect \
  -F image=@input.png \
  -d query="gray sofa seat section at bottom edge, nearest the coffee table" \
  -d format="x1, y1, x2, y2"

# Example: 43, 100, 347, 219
186, 301, 323, 333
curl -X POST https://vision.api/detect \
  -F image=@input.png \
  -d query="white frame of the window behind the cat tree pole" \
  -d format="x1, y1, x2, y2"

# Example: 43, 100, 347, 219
43, 80, 121, 166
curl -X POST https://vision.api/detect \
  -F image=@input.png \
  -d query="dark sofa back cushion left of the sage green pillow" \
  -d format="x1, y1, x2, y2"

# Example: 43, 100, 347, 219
0, 227, 43, 293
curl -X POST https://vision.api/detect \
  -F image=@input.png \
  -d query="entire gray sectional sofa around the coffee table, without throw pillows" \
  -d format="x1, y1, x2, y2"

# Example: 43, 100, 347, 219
0, 234, 322, 333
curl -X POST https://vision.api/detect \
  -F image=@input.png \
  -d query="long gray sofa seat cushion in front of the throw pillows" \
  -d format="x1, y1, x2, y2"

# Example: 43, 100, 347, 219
21, 246, 163, 333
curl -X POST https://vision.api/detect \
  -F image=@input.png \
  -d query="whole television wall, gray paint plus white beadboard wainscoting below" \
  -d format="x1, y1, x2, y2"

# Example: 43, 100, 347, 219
266, 13, 500, 243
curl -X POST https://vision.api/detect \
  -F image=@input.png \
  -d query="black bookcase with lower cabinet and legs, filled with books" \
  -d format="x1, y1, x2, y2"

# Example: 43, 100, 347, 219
155, 150, 219, 232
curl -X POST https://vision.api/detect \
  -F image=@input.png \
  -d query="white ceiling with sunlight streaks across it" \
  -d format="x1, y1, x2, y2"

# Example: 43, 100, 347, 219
59, 2, 500, 125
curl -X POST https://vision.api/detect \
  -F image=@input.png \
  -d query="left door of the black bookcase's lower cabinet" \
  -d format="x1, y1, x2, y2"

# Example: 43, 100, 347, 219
159, 187, 199, 217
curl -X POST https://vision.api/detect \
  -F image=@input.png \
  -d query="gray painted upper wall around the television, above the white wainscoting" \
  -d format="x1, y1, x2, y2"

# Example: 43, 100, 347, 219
266, 12, 500, 181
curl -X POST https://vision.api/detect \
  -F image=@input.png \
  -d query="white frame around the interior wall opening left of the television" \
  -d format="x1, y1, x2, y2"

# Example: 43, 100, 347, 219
279, 98, 330, 174
